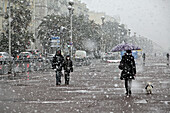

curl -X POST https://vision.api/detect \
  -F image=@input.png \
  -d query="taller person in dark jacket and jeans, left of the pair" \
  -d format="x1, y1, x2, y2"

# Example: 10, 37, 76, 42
52, 48, 64, 86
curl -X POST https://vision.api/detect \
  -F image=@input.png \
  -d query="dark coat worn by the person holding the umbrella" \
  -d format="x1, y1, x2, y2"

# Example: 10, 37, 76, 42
119, 54, 136, 80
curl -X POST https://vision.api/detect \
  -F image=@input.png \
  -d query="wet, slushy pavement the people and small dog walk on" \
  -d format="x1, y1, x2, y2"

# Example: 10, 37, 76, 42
0, 59, 170, 113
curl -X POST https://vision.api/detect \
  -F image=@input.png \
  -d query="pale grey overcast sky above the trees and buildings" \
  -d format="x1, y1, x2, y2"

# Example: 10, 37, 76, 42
81, 0, 170, 49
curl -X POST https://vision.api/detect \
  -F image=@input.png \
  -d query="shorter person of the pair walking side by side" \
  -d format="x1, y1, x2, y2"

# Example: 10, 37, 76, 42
64, 55, 73, 85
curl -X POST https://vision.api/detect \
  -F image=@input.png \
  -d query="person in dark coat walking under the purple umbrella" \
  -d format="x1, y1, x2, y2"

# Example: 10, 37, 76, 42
119, 50, 136, 95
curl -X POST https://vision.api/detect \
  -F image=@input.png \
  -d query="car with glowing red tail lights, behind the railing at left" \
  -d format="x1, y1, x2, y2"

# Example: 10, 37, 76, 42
17, 52, 34, 61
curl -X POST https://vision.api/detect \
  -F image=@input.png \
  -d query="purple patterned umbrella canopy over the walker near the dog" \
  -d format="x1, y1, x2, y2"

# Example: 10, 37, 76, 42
111, 43, 141, 52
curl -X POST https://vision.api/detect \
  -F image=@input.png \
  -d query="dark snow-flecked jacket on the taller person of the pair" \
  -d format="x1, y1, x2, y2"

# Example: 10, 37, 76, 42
52, 54, 64, 71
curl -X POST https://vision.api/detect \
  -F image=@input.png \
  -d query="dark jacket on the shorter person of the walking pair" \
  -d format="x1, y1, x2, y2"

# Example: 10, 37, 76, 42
64, 59, 73, 73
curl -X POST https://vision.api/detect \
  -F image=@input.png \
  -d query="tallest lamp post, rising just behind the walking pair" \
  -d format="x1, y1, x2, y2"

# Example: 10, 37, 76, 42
68, 0, 74, 58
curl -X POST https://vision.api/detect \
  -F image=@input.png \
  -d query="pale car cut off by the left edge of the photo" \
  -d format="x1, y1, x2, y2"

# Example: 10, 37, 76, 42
0, 52, 14, 61
